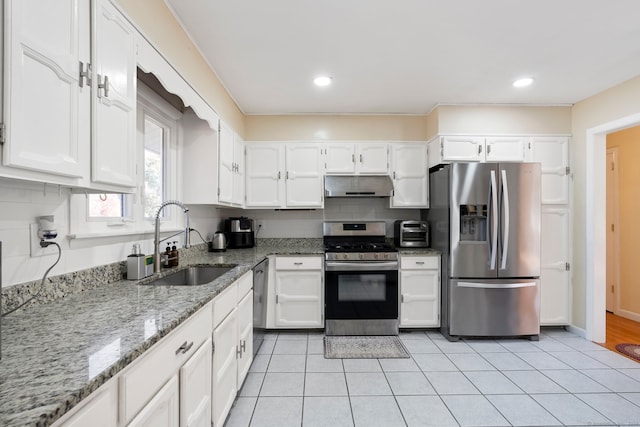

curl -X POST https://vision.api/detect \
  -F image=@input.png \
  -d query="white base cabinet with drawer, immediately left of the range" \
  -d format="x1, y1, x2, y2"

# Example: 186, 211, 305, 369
267, 256, 324, 328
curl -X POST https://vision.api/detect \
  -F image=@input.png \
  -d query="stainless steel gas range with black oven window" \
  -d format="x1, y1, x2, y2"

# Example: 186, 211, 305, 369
323, 221, 398, 335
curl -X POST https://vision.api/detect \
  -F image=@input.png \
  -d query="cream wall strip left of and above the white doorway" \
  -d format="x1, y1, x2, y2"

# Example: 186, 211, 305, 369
572, 76, 640, 328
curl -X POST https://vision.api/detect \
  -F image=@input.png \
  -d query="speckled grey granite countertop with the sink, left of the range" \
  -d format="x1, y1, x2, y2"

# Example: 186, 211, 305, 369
0, 242, 323, 426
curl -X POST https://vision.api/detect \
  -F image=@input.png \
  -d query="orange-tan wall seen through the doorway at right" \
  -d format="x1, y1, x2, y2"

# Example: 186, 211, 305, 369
607, 126, 640, 316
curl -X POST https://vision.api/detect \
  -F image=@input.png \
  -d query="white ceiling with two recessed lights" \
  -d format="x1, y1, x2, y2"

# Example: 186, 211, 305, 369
165, 0, 640, 114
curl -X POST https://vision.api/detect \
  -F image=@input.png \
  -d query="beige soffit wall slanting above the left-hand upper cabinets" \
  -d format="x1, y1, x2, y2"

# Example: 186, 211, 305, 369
116, 0, 244, 135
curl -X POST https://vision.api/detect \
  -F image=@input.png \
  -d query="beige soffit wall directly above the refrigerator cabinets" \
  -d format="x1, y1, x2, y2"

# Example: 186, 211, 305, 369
428, 105, 571, 136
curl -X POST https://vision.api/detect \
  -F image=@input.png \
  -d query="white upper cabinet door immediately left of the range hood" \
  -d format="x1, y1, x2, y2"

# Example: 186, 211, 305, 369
285, 143, 324, 208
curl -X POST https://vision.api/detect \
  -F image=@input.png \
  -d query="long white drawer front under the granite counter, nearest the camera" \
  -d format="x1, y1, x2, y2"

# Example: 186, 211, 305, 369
119, 305, 212, 423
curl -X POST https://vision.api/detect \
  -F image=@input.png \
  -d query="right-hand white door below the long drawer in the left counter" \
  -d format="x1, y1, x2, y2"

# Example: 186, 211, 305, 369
180, 338, 211, 427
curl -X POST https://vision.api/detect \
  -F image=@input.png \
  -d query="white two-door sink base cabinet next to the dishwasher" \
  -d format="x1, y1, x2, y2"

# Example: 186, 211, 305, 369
215, 271, 253, 427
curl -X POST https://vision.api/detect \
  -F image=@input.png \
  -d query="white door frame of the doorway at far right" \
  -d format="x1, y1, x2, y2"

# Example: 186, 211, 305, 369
585, 113, 640, 342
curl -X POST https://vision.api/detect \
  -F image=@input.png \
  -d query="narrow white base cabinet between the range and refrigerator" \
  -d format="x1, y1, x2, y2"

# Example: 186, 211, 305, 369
399, 255, 440, 328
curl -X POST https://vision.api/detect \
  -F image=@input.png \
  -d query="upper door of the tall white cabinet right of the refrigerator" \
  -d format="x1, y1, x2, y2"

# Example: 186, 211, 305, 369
528, 137, 570, 205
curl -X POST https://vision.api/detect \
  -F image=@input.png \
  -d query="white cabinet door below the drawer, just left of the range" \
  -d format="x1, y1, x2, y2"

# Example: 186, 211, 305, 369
275, 270, 323, 328
